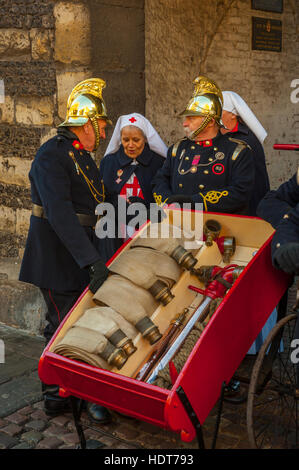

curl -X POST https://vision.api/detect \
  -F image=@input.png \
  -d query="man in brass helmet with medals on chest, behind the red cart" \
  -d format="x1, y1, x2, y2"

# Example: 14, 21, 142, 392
153, 77, 254, 214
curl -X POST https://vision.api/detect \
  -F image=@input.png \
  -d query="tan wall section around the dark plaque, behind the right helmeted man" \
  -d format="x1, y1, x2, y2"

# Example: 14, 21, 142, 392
145, 0, 299, 188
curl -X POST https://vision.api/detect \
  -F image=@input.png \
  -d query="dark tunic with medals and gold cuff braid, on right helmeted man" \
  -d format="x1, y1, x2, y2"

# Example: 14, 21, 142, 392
153, 133, 255, 214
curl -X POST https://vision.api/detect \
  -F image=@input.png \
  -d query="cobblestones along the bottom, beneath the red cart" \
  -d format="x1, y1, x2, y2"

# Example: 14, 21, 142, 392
0, 392, 253, 449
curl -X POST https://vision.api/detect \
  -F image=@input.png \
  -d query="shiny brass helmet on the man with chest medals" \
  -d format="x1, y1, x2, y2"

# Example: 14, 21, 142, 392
180, 75, 224, 139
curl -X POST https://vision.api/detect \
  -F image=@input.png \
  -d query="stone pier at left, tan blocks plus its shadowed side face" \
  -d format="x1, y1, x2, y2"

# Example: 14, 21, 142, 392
0, 0, 145, 257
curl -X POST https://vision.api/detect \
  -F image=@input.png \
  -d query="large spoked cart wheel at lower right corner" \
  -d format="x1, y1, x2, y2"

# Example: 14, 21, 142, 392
247, 314, 299, 449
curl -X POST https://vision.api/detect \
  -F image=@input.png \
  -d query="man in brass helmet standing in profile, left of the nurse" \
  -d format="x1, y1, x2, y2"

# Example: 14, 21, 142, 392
19, 78, 110, 422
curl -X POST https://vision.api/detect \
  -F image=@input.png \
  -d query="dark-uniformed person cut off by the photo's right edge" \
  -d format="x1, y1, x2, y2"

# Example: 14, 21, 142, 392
257, 173, 299, 389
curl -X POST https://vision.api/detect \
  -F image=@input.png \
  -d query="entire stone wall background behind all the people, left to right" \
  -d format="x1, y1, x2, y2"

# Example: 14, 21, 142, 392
0, 0, 299, 257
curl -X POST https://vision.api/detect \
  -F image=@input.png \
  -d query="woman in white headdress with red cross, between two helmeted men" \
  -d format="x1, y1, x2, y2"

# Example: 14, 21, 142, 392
96, 113, 167, 262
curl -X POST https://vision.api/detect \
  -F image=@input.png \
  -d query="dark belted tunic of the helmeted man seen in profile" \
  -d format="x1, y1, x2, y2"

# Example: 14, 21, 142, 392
20, 129, 101, 292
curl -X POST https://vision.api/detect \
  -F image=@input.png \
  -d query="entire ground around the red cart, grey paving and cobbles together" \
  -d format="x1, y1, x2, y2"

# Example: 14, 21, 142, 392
0, 284, 298, 450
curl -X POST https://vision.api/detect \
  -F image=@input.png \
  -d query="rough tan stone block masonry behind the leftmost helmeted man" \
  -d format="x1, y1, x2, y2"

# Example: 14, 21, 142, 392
0, 0, 91, 257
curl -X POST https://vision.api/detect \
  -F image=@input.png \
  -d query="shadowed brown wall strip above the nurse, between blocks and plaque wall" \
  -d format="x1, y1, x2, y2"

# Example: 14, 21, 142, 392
87, 0, 145, 143
